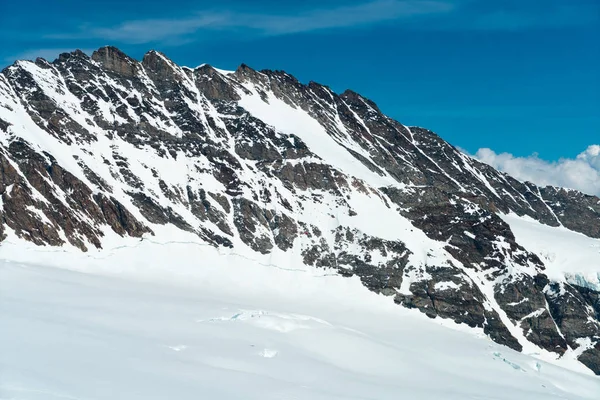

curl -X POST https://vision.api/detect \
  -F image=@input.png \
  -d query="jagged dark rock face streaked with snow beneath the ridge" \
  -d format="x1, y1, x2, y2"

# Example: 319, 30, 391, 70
0, 47, 600, 374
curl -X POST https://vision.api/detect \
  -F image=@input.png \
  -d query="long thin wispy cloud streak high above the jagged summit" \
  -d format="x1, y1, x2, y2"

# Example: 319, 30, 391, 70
46, 0, 456, 44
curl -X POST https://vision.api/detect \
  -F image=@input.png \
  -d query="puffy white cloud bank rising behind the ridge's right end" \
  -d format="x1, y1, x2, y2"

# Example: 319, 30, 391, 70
475, 144, 600, 196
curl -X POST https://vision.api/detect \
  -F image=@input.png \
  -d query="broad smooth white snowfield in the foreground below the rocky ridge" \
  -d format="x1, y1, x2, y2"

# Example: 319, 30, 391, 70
0, 239, 600, 400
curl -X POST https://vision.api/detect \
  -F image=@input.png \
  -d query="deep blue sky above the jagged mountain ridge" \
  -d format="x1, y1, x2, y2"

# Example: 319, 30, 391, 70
0, 0, 600, 163
